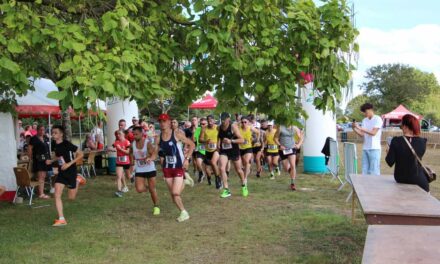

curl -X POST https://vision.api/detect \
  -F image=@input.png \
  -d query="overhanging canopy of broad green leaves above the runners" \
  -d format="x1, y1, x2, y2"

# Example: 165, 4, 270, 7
0, 0, 358, 123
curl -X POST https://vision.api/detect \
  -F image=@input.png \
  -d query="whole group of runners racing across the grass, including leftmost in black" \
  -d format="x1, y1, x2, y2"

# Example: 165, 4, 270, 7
47, 112, 303, 226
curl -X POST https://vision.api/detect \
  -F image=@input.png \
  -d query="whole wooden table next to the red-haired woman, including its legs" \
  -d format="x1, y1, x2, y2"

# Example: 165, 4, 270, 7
350, 174, 440, 225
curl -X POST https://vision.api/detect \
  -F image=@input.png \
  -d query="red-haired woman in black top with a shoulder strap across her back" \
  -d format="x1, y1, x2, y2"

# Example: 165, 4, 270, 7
385, 114, 429, 192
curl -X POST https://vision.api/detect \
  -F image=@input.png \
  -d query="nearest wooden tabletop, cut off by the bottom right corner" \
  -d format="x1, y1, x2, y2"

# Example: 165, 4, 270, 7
362, 225, 440, 264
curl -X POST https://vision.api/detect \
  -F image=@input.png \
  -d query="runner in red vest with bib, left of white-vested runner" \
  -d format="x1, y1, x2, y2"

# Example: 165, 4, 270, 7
113, 130, 131, 197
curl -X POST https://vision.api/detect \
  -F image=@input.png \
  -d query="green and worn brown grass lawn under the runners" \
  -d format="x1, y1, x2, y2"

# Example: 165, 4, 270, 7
0, 146, 440, 263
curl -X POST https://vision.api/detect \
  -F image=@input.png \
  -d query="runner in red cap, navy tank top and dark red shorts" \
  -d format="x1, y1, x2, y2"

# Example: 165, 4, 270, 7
156, 114, 194, 222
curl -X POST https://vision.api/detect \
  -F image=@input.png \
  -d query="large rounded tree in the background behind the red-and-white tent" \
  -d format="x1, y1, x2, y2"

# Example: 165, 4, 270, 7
361, 64, 440, 114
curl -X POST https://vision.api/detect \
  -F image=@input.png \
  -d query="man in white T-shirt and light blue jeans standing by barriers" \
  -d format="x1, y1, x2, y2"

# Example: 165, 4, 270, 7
352, 103, 383, 175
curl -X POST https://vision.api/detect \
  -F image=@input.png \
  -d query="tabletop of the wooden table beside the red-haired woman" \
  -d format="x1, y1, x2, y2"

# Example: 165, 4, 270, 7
350, 175, 440, 218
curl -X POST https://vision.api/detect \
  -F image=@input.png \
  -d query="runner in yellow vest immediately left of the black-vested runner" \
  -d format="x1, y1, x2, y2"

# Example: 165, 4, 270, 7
199, 115, 221, 189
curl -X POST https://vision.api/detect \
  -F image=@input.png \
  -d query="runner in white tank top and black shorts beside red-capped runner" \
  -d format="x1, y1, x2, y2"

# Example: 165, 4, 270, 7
130, 127, 160, 215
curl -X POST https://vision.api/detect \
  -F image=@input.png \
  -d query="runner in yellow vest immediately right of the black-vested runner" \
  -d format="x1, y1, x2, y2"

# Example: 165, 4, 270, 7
239, 116, 260, 183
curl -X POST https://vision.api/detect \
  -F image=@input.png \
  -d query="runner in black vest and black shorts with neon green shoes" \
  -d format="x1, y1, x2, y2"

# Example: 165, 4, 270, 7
218, 112, 248, 198
